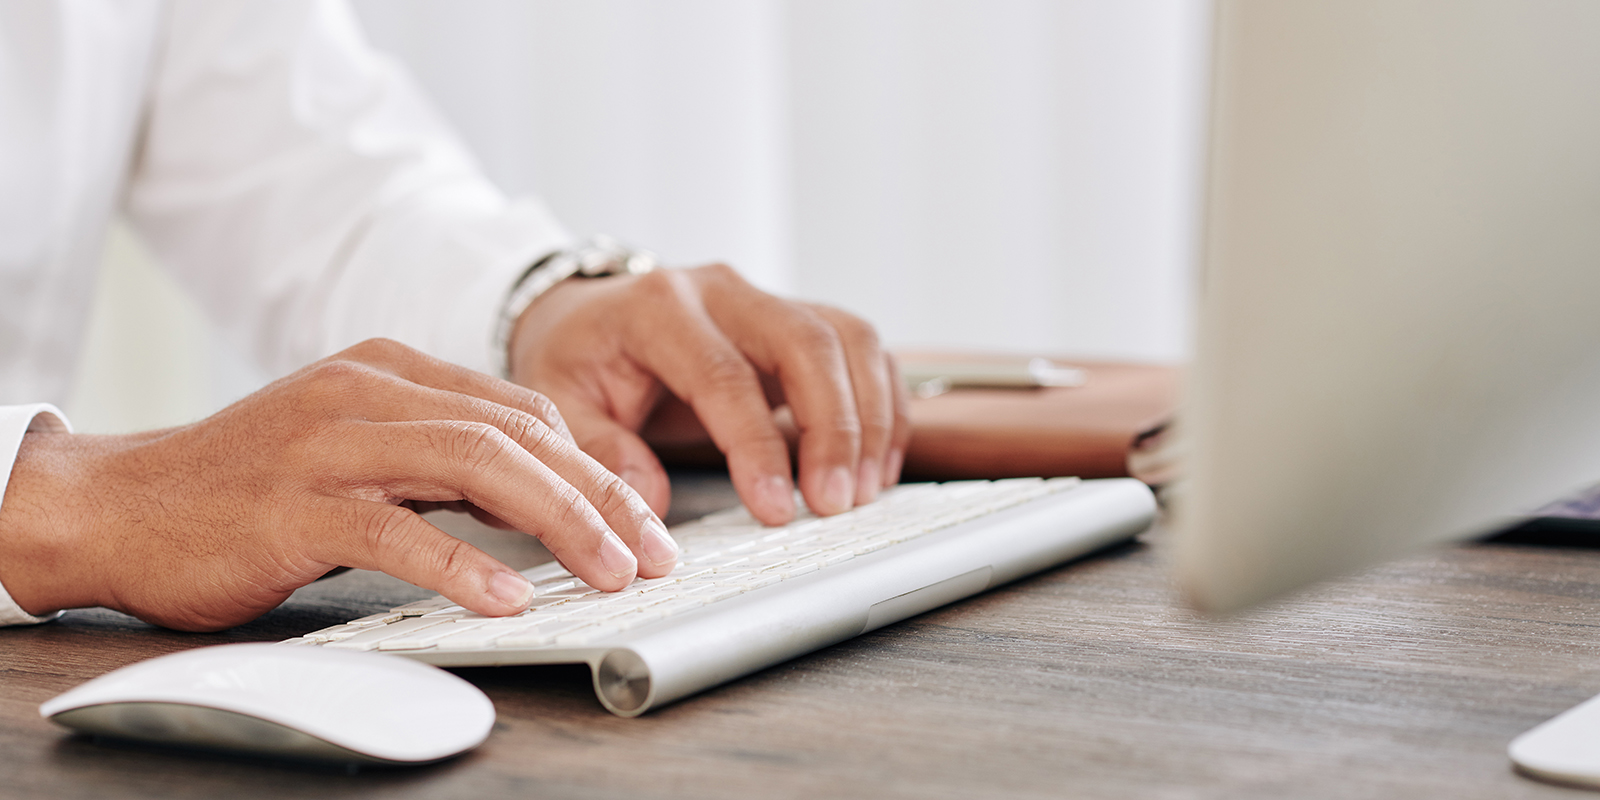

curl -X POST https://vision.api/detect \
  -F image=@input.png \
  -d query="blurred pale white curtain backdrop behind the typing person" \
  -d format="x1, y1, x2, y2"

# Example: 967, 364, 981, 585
67, 0, 1210, 432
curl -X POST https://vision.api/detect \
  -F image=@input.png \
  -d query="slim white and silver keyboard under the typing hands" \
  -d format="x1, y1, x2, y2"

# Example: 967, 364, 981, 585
283, 478, 1155, 717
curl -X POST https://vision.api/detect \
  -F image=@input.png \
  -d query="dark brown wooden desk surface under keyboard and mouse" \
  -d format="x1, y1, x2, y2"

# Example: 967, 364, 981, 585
0, 478, 1600, 800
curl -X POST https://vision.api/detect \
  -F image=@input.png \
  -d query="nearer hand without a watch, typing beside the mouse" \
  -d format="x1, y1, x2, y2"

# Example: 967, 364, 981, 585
0, 339, 677, 630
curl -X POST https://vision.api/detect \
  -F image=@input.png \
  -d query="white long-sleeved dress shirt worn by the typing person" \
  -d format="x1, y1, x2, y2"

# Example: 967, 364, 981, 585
0, 0, 570, 622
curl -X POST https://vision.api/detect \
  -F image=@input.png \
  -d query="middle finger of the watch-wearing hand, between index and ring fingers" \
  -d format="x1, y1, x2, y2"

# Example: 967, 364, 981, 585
706, 270, 861, 515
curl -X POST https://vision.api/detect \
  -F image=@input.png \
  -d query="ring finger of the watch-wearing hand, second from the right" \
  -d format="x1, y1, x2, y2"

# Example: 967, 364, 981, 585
806, 304, 894, 506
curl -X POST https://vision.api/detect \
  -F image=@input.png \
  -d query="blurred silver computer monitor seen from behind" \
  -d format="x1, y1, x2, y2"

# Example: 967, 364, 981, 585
1173, 0, 1600, 611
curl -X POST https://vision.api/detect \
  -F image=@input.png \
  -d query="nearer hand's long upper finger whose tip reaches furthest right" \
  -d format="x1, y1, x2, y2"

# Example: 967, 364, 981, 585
308, 371, 678, 578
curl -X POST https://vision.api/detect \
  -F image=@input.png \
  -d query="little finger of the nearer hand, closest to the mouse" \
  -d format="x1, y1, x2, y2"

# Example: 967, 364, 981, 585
302, 498, 533, 616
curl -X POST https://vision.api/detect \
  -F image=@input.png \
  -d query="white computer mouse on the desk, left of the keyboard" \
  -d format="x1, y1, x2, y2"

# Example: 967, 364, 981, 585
38, 645, 494, 765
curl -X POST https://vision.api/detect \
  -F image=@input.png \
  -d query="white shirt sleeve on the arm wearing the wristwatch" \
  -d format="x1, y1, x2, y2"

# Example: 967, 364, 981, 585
125, 0, 571, 373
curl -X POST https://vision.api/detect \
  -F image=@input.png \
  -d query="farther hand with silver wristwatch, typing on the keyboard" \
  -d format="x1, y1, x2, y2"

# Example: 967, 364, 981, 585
510, 264, 910, 525
